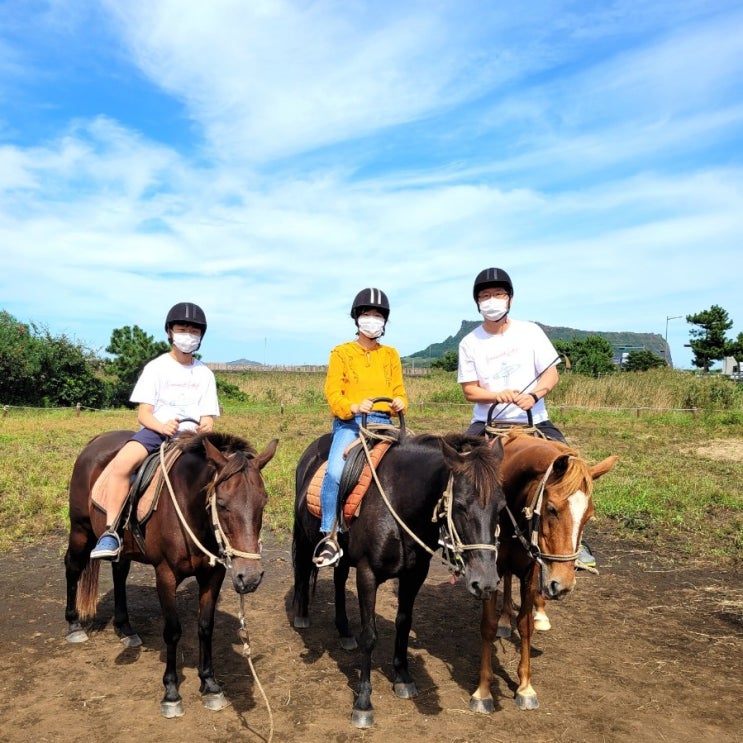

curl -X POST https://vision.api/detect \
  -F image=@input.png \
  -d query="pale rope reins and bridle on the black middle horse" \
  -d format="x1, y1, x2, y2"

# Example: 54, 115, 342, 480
359, 424, 498, 575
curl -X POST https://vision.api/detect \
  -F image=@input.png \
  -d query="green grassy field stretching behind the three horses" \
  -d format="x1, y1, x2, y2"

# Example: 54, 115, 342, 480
0, 370, 743, 561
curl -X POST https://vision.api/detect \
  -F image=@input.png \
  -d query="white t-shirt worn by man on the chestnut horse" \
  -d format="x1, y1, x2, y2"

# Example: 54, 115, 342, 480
457, 319, 559, 423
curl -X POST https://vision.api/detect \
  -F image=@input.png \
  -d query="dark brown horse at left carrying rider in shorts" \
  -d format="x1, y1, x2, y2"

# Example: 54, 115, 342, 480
65, 431, 278, 717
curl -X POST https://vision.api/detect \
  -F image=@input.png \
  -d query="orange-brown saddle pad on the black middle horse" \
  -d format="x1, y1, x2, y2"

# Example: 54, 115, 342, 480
307, 439, 395, 527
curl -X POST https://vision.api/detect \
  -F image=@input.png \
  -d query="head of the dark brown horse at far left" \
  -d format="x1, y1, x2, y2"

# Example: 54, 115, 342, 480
202, 434, 279, 594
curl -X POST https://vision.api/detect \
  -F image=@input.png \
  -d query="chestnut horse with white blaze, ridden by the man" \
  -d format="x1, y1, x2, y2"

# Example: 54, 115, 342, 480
470, 432, 617, 713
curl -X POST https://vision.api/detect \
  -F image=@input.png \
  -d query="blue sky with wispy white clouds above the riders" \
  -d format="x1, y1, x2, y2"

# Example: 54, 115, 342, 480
0, 0, 743, 367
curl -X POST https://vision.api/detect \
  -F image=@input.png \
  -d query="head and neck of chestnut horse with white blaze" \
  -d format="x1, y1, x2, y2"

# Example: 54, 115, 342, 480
503, 434, 617, 599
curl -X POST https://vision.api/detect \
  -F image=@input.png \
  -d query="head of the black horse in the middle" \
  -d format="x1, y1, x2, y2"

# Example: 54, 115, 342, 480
441, 434, 506, 599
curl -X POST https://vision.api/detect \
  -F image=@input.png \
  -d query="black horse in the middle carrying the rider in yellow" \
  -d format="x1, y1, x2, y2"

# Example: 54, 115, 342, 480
293, 434, 505, 728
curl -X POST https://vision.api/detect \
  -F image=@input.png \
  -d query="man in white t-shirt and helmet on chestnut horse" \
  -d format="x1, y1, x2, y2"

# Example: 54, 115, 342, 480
457, 268, 565, 442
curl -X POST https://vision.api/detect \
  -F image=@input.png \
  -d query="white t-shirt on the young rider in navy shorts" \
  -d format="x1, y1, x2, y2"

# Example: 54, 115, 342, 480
129, 353, 219, 431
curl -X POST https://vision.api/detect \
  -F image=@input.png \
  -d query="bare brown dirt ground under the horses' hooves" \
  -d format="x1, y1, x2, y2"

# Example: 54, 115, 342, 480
0, 528, 743, 743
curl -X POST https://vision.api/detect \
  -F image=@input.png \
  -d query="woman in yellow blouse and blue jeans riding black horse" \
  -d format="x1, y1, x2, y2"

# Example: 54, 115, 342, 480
314, 288, 408, 567
